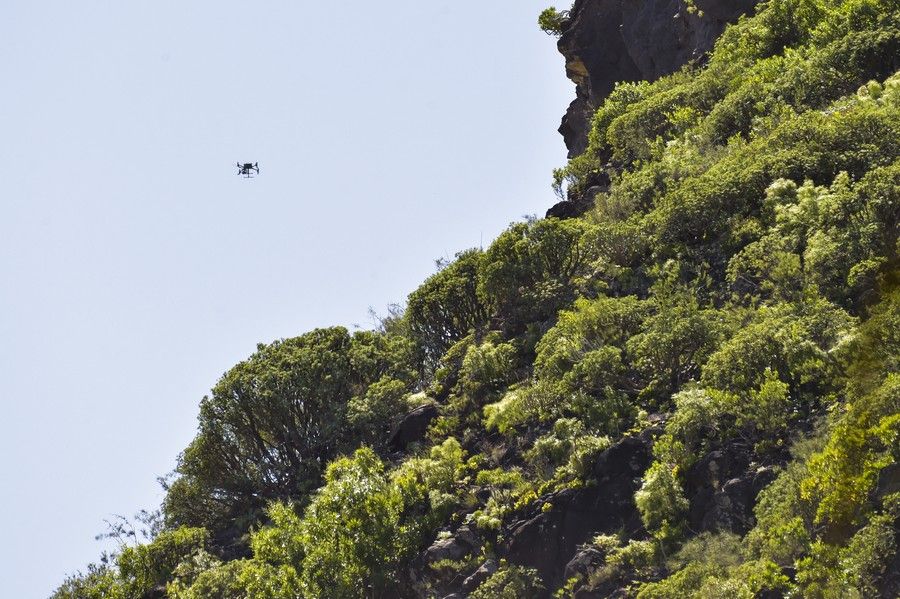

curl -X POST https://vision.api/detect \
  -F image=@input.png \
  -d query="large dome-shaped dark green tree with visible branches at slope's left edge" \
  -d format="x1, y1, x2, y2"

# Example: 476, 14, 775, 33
165, 327, 417, 539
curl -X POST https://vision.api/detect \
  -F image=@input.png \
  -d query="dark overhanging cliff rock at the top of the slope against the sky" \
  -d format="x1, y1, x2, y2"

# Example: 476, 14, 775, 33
558, 0, 759, 158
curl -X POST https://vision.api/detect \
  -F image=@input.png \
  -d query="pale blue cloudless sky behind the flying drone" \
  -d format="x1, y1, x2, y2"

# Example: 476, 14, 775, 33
0, 0, 574, 599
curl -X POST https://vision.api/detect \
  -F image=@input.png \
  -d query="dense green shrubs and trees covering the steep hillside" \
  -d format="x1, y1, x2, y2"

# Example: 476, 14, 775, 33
54, 0, 900, 599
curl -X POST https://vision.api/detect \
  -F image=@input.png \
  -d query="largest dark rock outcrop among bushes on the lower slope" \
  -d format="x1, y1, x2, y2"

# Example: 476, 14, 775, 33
501, 434, 652, 588
